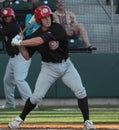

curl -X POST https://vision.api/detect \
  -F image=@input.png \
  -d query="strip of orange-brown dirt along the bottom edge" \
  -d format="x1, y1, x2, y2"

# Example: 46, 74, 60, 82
0, 124, 119, 130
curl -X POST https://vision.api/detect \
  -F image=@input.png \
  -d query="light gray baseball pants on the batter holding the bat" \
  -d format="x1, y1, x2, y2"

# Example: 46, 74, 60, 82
30, 59, 86, 104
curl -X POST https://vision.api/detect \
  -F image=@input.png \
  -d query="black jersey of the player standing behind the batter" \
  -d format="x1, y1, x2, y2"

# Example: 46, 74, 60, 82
0, 21, 20, 57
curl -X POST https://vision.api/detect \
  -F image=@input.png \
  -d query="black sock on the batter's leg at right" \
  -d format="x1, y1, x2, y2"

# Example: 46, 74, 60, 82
78, 97, 89, 122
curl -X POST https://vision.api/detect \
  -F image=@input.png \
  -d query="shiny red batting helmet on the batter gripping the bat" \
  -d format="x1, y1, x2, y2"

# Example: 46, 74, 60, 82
35, 5, 52, 25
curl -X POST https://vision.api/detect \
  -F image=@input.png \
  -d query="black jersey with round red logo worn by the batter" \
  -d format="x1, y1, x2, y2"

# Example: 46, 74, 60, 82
27, 23, 69, 63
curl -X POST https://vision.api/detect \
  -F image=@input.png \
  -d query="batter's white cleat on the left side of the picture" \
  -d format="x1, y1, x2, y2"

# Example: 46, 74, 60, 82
8, 117, 23, 129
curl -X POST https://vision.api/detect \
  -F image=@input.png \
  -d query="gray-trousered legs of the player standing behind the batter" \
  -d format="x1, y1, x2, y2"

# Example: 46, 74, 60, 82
4, 54, 32, 108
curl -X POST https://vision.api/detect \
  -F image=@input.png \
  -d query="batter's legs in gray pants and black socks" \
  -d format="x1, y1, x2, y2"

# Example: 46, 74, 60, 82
9, 59, 94, 130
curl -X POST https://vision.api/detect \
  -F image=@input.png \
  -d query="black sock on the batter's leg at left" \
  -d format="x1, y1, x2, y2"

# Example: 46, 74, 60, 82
20, 98, 36, 121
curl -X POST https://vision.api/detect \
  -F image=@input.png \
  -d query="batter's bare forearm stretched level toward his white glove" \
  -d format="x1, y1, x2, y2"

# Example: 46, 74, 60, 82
20, 37, 44, 46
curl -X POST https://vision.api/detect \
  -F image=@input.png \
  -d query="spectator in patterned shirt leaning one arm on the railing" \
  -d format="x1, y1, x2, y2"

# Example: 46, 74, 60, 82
53, 0, 94, 49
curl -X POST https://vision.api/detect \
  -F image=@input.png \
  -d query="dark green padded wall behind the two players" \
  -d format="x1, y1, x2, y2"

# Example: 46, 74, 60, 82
0, 53, 119, 98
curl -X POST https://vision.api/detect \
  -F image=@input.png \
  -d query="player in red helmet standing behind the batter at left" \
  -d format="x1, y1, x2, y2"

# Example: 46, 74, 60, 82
0, 8, 32, 109
